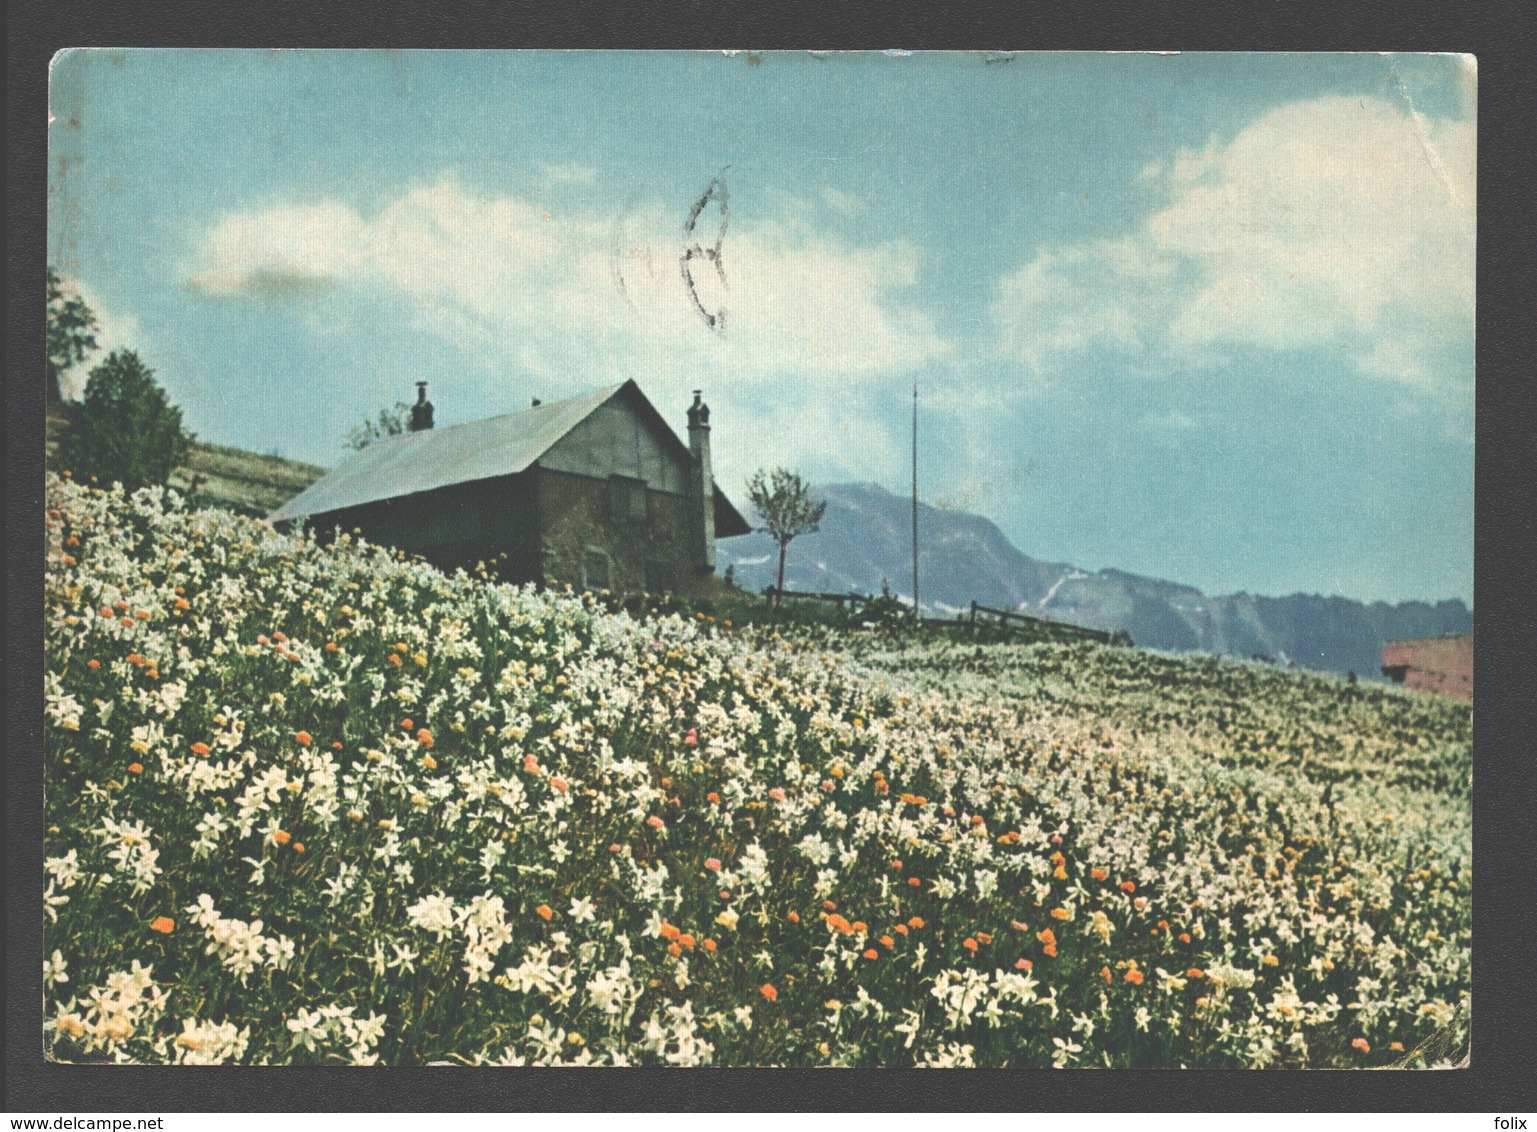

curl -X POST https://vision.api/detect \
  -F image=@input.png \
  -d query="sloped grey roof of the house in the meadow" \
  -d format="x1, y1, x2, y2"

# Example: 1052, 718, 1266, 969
267, 380, 750, 537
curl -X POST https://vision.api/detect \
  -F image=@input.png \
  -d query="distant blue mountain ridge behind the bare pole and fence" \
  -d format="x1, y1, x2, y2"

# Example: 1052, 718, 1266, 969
719, 483, 1472, 678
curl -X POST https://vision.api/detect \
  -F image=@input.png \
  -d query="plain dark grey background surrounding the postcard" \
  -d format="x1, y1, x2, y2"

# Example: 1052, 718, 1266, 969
0, 0, 1537, 1114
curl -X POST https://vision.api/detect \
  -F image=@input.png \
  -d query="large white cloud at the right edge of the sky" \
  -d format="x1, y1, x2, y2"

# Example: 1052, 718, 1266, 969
994, 97, 1476, 392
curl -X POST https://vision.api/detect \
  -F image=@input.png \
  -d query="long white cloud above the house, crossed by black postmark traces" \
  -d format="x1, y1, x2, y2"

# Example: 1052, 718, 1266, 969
188, 180, 951, 478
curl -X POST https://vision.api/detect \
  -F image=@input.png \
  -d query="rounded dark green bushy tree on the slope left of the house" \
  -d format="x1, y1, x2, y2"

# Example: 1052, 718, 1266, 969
58, 351, 192, 491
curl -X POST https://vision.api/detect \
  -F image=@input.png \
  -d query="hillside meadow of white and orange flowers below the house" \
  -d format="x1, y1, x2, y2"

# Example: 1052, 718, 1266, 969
43, 478, 1472, 1067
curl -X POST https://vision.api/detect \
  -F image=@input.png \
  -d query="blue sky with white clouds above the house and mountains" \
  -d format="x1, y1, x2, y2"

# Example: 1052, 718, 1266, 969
49, 51, 1476, 603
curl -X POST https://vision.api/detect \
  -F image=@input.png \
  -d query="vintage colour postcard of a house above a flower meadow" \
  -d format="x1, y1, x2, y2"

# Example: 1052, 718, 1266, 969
40, 49, 1477, 1069
